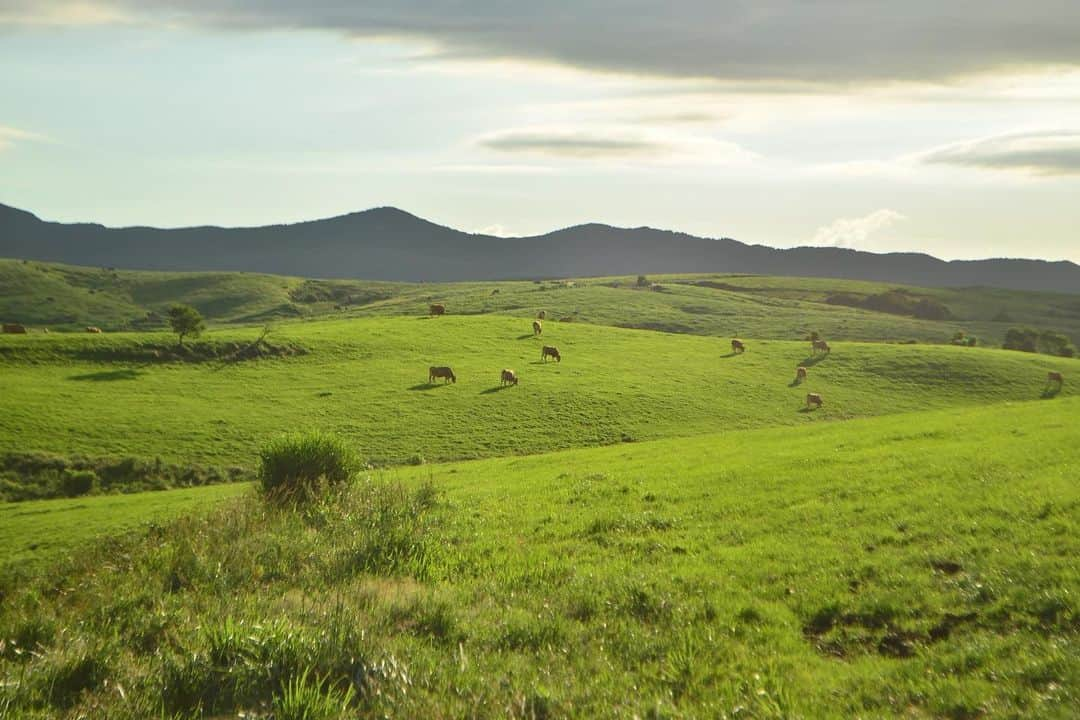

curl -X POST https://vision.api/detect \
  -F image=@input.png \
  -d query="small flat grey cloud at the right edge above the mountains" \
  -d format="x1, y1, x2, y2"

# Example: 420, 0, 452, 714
921, 130, 1080, 175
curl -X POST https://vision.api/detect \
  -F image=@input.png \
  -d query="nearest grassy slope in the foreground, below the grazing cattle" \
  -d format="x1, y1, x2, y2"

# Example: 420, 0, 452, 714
0, 398, 1080, 719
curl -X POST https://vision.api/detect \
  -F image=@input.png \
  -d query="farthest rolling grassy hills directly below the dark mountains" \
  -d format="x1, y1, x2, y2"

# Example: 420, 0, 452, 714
0, 260, 1080, 345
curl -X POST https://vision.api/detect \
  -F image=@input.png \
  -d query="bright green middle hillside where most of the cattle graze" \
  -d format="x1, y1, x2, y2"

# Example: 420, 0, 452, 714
0, 315, 1077, 467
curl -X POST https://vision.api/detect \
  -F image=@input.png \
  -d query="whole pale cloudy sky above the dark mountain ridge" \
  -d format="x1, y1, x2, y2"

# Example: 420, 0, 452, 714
0, 0, 1080, 262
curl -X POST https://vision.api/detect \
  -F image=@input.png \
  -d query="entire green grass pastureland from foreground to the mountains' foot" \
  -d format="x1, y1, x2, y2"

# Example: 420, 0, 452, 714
0, 266, 1080, 720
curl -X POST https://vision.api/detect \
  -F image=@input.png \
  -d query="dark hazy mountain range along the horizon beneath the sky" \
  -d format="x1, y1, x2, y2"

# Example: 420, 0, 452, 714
0, 204, 1080, 293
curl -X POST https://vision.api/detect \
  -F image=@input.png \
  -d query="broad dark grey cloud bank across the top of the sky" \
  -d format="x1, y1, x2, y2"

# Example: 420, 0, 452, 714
0, 0, 1080, 85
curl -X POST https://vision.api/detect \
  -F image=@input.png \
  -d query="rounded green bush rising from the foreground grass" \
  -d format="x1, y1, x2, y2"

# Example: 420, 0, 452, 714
259, 432, 363, 503
